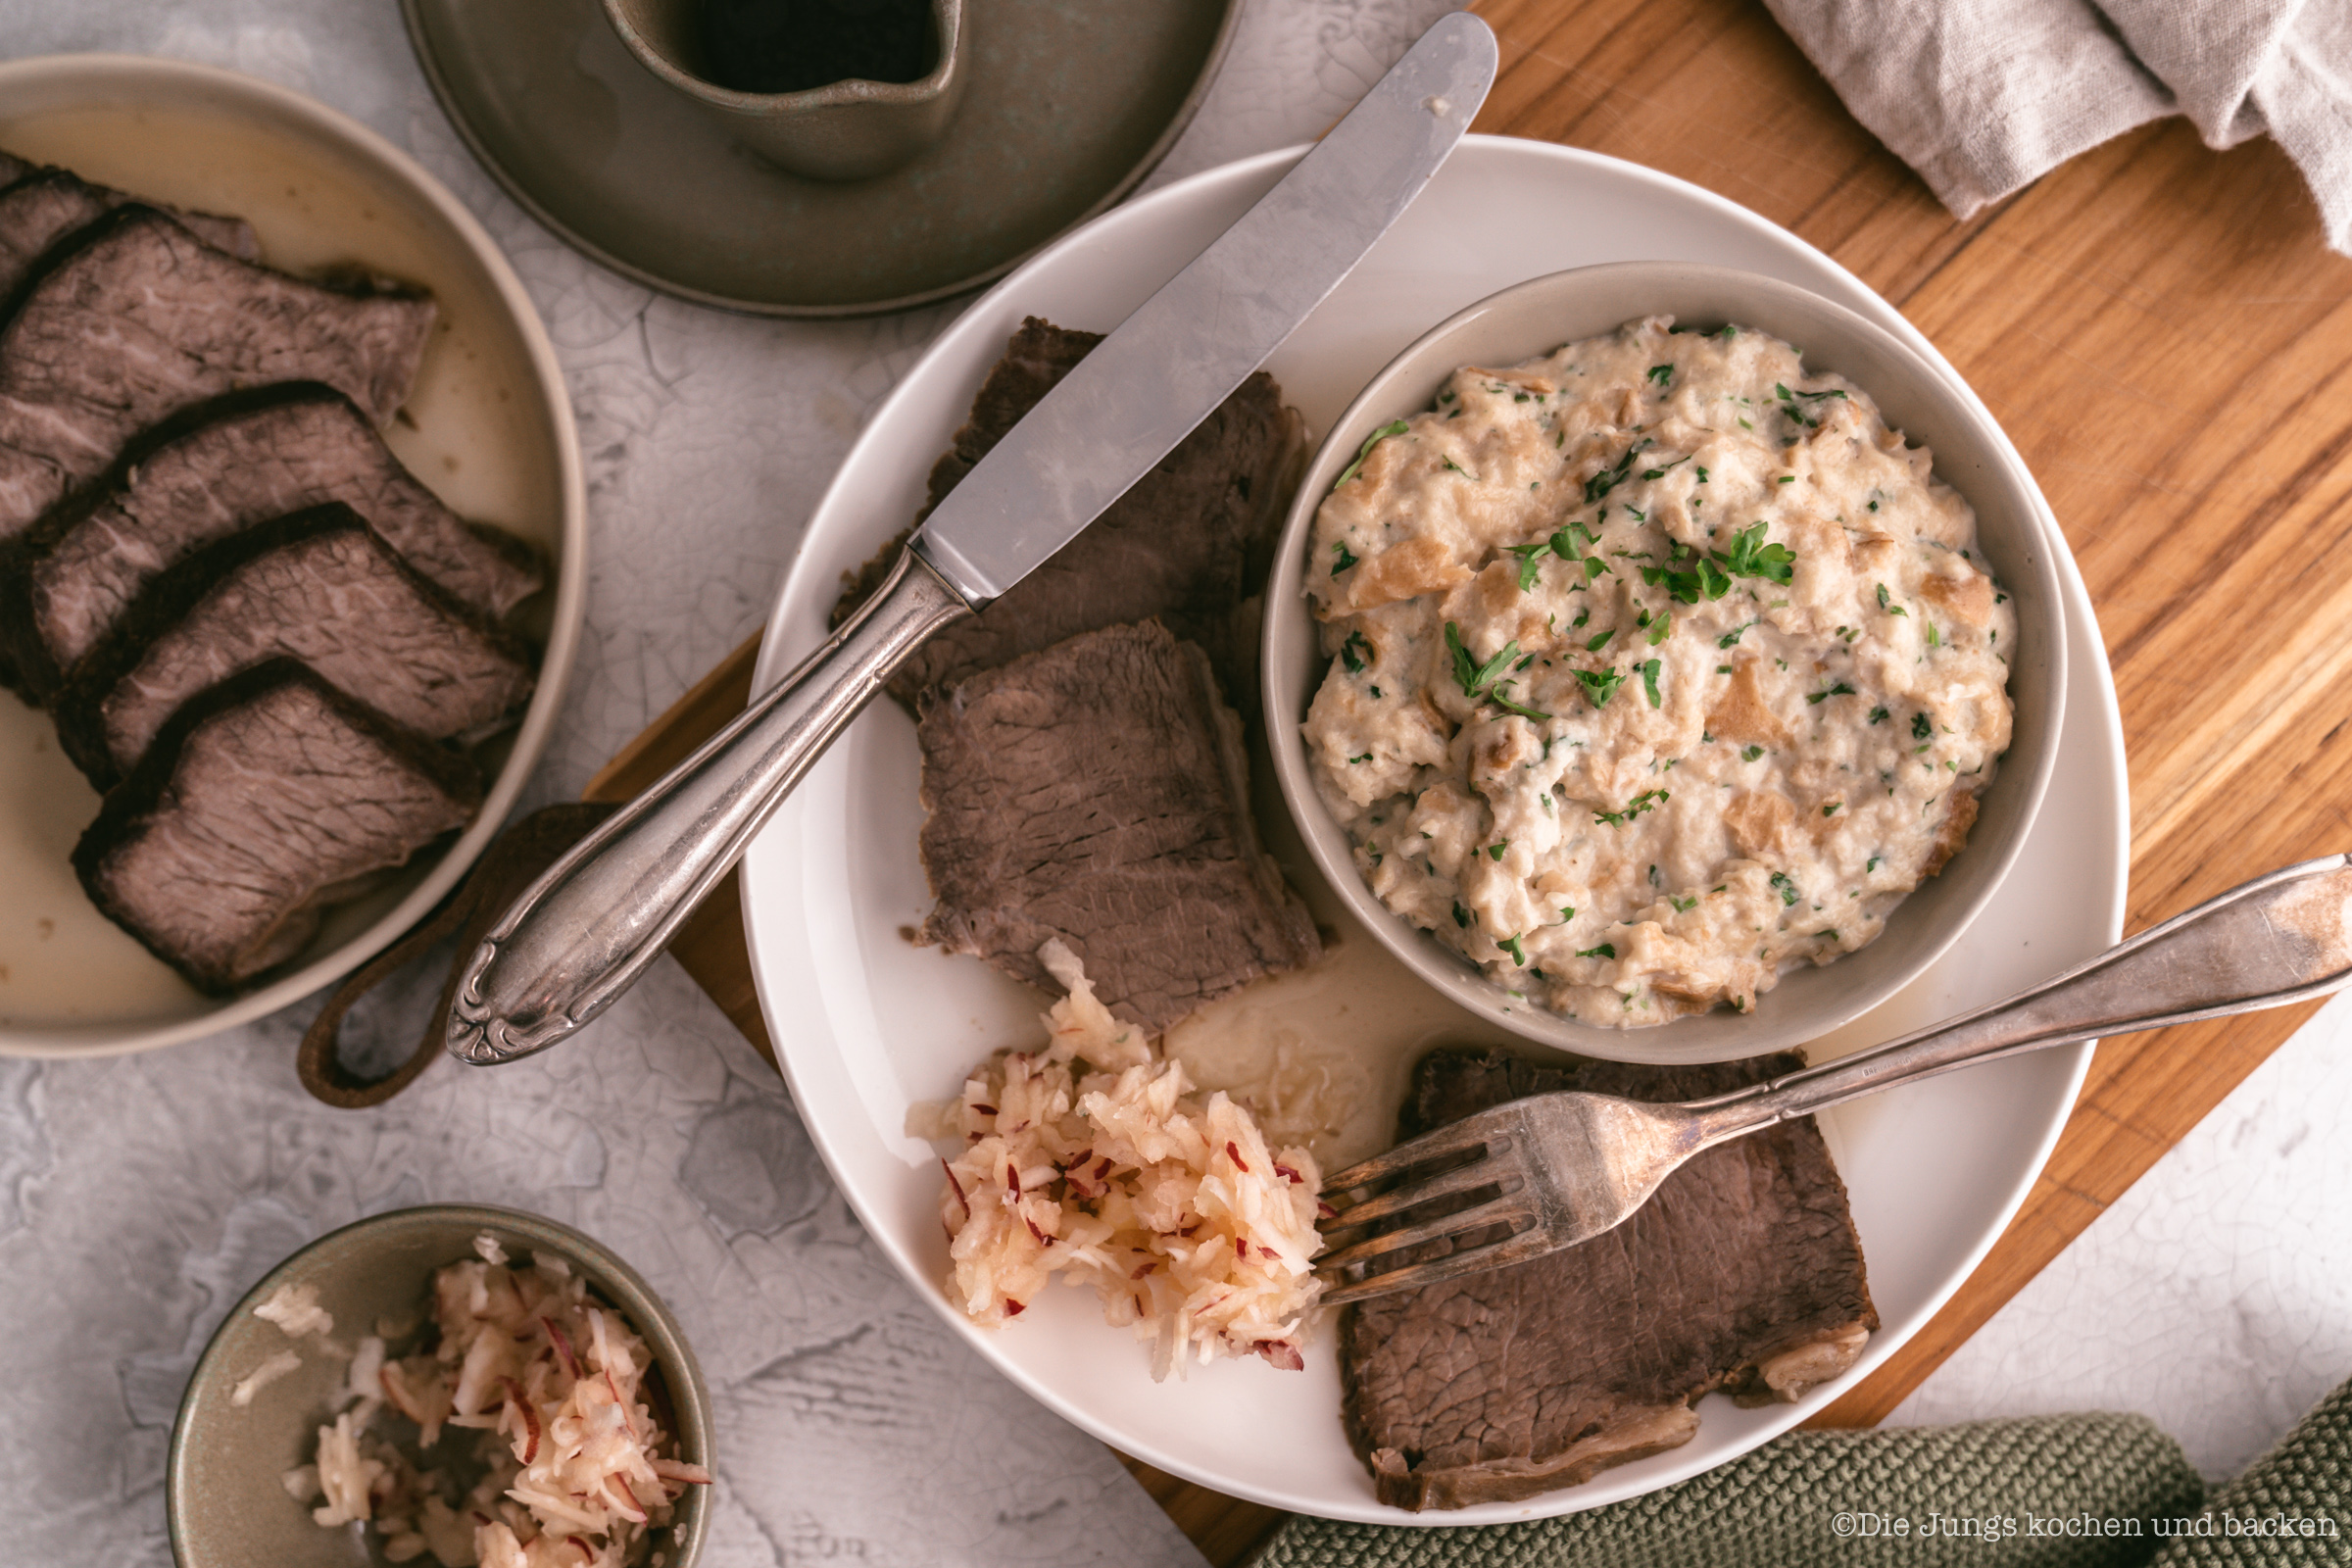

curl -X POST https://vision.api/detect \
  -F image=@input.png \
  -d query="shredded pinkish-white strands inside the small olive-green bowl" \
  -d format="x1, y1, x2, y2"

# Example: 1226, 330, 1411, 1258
287, 1237, 710, 1568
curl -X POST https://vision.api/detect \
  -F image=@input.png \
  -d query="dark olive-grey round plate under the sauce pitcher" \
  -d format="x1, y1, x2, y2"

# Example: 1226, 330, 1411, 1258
402, 0, 1240, 318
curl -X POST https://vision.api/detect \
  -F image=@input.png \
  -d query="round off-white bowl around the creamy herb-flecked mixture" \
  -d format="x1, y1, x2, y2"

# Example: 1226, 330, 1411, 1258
1263, 264, 2065, 1062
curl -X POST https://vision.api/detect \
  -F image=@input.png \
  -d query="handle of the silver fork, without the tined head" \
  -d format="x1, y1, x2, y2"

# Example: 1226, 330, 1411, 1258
1689, 856, 2352, 1152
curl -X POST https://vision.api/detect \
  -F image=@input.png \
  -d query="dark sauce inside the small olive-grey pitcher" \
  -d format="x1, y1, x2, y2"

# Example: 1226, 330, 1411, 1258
701, 0, 939, 92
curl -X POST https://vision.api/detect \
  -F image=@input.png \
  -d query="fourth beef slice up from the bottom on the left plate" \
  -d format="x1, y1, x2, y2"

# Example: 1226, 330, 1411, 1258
0, 205, 433, 538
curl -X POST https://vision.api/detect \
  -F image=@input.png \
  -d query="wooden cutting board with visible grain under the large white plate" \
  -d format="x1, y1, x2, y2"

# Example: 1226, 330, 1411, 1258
588, 0, 2352, 1542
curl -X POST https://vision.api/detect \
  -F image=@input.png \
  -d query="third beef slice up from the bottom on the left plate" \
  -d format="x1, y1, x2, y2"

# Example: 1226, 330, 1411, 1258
0, 381, 546, 701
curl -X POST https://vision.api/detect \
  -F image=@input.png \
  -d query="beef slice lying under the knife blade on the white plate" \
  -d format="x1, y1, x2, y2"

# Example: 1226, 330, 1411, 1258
835, 318, 1305, 706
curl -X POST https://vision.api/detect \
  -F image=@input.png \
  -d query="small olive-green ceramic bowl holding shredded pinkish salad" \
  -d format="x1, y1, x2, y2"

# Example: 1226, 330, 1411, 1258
165, 1203, 710, 1568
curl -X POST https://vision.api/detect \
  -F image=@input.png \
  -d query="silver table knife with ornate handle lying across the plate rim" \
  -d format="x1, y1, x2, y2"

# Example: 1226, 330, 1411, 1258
447, 12, 1495, 1065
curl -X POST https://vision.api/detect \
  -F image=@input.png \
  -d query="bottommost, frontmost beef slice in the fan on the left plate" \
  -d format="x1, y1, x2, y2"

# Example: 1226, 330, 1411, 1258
73, 659, 482, 995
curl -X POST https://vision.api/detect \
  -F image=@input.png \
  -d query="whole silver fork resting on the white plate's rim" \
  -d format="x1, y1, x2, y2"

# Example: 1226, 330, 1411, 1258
1315, 856, 2352, 1304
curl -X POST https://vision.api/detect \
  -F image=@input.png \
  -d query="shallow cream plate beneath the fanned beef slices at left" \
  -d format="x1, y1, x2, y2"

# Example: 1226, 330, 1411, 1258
0, 54, 588, 1055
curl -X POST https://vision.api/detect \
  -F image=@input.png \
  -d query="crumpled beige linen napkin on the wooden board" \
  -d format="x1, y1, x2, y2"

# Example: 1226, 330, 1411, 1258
1766, 0, 2352, 252
